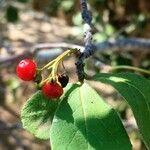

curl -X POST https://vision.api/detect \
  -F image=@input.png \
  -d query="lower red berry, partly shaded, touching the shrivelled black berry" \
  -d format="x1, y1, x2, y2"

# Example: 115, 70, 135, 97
42, 83, 63, 99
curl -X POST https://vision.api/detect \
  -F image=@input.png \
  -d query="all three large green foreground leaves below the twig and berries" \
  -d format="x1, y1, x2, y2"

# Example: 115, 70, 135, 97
21, 73, 150, 150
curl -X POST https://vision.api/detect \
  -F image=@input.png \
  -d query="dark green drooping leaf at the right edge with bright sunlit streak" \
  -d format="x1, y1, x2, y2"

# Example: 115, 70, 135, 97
93, 73, 150, 149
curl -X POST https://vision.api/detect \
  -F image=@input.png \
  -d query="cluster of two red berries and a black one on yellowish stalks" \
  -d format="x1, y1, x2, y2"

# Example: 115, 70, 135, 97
16, 59, 69, 99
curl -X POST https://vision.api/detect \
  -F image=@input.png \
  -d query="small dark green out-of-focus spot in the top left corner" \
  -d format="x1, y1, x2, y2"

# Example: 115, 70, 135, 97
6, 5, 19, 22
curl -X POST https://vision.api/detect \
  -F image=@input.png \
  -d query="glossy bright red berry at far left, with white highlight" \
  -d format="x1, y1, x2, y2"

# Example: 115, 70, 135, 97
16, 59, 36, 81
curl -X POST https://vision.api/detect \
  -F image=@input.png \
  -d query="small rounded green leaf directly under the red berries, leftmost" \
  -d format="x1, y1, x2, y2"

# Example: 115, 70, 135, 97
21, 91, 58, 139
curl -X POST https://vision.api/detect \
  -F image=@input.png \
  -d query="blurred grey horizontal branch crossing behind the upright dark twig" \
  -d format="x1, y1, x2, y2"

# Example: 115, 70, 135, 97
0, 38, 150, 67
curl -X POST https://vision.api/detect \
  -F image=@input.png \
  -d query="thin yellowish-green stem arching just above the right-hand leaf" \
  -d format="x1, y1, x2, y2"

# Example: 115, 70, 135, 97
110, 66, 150, 75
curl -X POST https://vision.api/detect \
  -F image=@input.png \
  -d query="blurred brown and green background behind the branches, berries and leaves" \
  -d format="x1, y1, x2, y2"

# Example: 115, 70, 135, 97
0, 0, 150, 150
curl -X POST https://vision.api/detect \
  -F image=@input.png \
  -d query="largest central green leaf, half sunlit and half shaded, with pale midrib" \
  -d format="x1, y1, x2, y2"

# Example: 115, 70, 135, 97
50, 83, 132, 150
